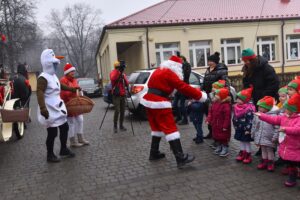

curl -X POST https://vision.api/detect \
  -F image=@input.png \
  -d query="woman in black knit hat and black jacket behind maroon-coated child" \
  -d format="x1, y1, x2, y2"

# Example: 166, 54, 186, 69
202, 52, 228, 139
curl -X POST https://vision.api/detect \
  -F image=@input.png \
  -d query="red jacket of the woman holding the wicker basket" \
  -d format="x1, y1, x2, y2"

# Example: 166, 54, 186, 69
60, 76, 79, 117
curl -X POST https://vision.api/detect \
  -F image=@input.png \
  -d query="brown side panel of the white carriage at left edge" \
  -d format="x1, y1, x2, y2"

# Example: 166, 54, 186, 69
0, 108, 29, 123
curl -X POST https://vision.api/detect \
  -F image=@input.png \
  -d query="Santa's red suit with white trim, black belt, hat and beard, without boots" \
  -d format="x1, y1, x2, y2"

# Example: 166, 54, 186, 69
141, 56, 207, 141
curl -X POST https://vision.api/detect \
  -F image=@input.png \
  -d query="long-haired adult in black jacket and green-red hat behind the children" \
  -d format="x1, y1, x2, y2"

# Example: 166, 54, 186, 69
242, 48, 279, 105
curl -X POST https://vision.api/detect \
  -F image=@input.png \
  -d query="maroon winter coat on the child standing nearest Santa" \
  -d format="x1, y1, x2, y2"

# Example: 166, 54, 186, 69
207, 98, 231, 142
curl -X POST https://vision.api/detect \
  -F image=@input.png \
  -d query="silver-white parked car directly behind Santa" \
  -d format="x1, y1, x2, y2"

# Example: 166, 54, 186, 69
127, 69, 236, 118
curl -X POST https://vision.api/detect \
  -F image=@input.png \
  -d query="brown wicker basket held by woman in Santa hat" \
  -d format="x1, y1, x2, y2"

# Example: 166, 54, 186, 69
66, 96, 95, 115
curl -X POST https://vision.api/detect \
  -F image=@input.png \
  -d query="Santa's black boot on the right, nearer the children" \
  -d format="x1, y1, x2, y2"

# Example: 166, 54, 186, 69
169, 139, 195, 169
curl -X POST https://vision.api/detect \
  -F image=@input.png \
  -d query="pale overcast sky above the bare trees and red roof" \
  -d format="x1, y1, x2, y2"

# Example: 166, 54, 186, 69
36, 0, 162, 29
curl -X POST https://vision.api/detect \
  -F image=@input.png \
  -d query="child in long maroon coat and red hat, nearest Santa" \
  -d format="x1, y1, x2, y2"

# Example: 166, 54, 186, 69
206, 88, 231, 157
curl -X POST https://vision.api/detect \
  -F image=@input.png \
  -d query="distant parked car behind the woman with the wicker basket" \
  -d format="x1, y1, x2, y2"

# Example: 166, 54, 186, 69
77, 78, 102, 97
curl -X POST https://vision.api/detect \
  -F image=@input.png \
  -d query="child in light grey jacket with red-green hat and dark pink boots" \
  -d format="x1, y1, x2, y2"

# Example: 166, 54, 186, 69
251, 96, 278, 172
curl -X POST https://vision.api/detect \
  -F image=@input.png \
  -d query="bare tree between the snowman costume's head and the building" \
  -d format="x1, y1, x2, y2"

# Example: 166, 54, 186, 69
49, 3, 102, 77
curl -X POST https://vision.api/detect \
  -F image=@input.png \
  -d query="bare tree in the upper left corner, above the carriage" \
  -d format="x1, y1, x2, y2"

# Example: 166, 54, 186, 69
0, 0, 37, 73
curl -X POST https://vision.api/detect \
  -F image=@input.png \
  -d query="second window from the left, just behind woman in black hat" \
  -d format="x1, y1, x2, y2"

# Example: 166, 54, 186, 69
189, 41, 211, 67
